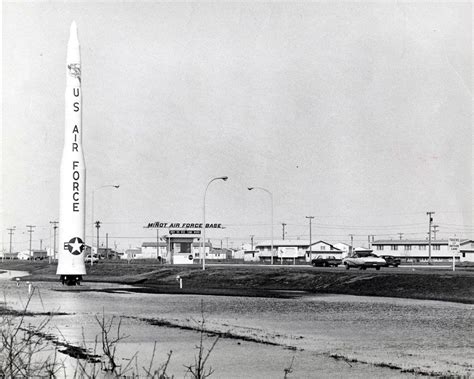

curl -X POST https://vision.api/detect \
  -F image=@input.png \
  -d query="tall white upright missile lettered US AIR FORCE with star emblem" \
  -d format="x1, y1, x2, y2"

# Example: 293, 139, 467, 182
56, 22, 86, 285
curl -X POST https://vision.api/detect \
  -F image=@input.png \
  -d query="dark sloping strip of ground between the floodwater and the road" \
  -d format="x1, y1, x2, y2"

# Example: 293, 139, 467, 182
0, 260, 474, 304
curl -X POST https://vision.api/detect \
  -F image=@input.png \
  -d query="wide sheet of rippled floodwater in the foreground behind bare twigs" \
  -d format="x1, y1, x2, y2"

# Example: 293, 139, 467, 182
3, 282, 474, 378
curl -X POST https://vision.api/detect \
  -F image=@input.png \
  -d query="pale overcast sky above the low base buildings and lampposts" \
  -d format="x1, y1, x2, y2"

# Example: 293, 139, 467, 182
1, 1, 474, 250
